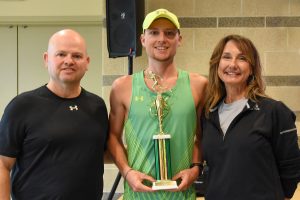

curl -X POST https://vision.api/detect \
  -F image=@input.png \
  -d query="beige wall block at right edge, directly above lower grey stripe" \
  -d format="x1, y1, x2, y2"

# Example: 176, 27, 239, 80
265, 52, 300, 76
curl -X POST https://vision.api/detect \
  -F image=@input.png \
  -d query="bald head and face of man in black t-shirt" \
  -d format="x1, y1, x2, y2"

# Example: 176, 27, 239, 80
44, 30, 89, 86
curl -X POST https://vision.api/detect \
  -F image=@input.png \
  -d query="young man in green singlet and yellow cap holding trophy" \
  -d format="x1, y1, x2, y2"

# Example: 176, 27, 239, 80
108, 9, 207, 199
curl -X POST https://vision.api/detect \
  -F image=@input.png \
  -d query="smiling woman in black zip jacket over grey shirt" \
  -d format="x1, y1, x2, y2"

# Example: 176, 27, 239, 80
202, 35, 300, 200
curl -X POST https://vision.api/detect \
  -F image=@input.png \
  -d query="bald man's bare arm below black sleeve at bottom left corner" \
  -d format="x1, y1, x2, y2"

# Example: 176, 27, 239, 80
0, 155, 16, 200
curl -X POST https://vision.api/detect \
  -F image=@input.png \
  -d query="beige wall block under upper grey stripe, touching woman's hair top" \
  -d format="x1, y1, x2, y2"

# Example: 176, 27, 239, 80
195, 28, 240, 52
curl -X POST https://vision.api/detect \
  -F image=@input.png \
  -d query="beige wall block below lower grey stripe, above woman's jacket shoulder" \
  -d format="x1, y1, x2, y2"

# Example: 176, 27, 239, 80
266, 86, 300, 111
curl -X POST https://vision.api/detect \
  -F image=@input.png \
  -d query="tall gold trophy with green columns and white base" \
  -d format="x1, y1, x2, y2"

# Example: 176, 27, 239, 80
146, 70, 178, 190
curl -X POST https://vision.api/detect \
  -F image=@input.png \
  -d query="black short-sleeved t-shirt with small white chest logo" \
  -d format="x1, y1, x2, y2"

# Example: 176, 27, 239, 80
0, 86, 108, 200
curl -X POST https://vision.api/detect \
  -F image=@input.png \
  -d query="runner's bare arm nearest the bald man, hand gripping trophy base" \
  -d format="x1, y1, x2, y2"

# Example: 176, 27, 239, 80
108, 76, 155, 192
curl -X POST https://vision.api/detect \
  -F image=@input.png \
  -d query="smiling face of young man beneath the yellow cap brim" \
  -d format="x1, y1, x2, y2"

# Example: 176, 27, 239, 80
141, 18, 181, 61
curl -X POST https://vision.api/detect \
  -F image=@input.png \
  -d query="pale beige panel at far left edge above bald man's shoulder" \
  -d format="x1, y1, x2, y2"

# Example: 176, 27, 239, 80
0, 26, 18, 116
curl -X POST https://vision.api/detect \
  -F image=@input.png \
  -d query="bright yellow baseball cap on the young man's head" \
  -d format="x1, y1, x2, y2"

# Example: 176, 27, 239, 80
143, 8, 180, 31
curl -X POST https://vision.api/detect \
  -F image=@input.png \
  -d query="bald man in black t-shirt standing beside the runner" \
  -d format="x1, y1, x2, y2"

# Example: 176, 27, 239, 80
0, 29, 108, 200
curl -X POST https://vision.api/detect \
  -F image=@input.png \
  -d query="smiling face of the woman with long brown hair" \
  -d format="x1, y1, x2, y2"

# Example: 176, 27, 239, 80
218, 40, 252, 90
